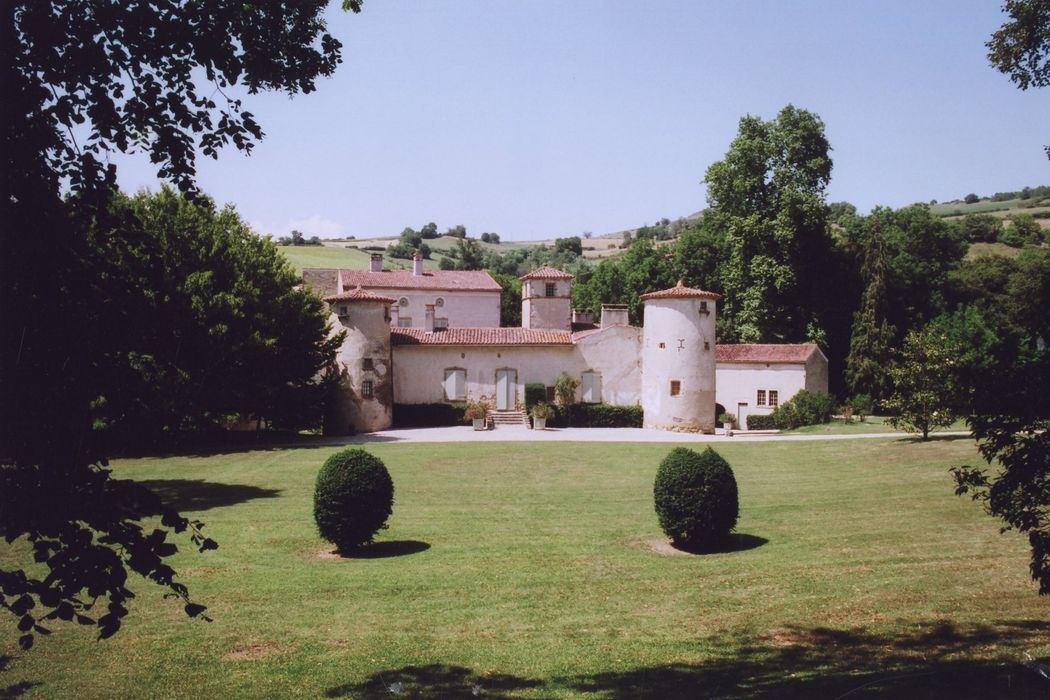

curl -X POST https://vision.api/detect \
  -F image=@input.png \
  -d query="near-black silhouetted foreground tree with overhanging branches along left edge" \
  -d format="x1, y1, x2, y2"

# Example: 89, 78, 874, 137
0, 0, 359, 646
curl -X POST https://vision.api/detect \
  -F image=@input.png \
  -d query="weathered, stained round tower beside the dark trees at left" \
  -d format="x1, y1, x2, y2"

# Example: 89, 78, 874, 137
324, 287, 396, 434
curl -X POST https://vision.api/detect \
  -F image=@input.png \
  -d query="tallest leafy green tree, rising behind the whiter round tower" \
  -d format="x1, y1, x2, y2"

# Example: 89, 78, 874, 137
705, 105, 832, 342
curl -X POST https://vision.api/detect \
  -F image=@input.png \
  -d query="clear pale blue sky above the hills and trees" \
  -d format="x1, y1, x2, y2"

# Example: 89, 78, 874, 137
110, 0, 1050, 240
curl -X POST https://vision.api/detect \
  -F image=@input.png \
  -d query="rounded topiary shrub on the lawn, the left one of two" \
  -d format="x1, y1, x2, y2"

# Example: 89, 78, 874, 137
314, 449, 394, 552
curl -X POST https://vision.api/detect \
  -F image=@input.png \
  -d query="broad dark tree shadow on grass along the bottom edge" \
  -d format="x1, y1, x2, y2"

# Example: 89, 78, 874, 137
327, 620, 1050, 700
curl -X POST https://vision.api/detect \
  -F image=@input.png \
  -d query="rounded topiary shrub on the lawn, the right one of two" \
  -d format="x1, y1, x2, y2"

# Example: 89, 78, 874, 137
653, 447, 740, 551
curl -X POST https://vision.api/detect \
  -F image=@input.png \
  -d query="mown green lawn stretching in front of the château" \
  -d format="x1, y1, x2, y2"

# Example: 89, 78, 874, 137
0, 438, 1050, 698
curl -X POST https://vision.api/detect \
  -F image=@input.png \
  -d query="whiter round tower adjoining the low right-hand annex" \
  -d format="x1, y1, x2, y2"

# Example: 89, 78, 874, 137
642, 281, 721, 432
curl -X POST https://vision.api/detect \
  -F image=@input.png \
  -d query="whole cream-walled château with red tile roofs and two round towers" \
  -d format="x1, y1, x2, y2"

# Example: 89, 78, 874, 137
303, 255, 827, 434
